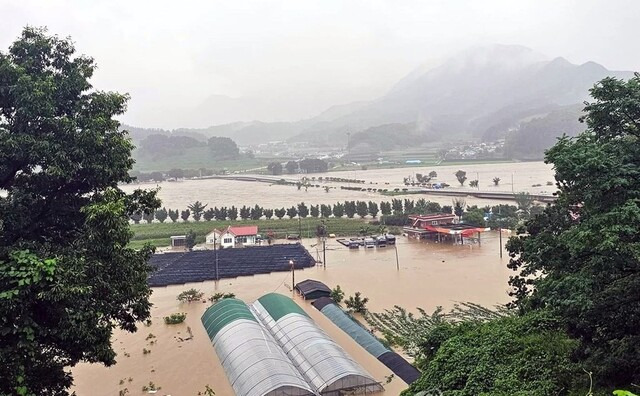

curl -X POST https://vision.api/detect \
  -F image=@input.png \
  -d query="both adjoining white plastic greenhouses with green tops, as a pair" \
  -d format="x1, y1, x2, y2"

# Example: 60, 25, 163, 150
202, 293, 384, 396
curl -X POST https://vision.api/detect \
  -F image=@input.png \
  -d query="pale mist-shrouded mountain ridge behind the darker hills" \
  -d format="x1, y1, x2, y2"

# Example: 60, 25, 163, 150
122, 45, 633, 153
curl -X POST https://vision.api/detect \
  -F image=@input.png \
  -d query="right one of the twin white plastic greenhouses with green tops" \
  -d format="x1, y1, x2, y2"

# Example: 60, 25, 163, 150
252, 293, 384, 395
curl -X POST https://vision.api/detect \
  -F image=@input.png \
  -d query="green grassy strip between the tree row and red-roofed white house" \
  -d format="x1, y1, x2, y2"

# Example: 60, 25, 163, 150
129, 217, 401, 249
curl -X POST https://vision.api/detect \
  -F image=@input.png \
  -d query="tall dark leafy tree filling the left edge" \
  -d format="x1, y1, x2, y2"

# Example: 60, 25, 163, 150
0, 27, 160, 395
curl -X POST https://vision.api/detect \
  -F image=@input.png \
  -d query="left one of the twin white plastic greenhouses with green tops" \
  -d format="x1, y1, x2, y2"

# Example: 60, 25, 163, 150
202, 298, 315, 396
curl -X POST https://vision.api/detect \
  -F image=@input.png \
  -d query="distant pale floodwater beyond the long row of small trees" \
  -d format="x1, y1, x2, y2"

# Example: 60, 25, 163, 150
122, 162, 556, 209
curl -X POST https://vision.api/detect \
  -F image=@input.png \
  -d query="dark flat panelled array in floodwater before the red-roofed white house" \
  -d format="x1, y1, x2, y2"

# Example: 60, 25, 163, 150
148, 243, 315, 287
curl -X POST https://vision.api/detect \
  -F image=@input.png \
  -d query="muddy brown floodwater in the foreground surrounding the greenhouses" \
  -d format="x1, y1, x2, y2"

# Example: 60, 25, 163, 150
73, 232, 511, 396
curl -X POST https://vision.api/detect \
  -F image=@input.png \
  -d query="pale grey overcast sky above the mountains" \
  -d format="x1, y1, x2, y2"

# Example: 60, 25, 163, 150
0, 0, 640, 128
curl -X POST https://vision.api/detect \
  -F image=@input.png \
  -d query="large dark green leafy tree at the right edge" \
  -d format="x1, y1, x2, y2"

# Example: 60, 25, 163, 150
507, 74, 640, 386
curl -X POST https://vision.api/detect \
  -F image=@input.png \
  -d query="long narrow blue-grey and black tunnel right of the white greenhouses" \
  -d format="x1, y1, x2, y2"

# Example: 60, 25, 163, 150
312, 297, 420, 385
